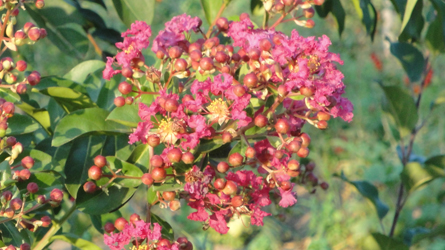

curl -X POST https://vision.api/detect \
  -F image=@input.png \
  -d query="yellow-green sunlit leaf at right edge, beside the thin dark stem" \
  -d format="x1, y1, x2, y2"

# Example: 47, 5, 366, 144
400, 155, 445, 192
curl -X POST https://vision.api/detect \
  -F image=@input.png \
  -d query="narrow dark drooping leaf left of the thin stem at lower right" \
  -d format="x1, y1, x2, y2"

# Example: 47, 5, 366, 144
334, 172, 389, 220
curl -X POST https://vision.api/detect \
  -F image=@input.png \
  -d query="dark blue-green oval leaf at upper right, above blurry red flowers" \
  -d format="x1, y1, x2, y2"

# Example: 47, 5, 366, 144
390, 42, 425, 82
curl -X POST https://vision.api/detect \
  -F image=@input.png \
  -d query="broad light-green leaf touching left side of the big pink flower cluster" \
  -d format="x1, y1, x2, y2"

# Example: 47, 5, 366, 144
52, 108, 131, 147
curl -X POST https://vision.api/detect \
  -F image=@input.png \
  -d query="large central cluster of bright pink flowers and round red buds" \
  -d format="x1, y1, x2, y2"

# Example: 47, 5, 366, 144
99, 5, 353, 246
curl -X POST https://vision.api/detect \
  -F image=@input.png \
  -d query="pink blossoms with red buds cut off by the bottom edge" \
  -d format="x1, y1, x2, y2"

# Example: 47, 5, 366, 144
104, 213, 193, 250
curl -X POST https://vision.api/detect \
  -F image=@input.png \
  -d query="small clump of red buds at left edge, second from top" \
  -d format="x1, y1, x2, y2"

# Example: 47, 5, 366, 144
0, 57, 41, 94
